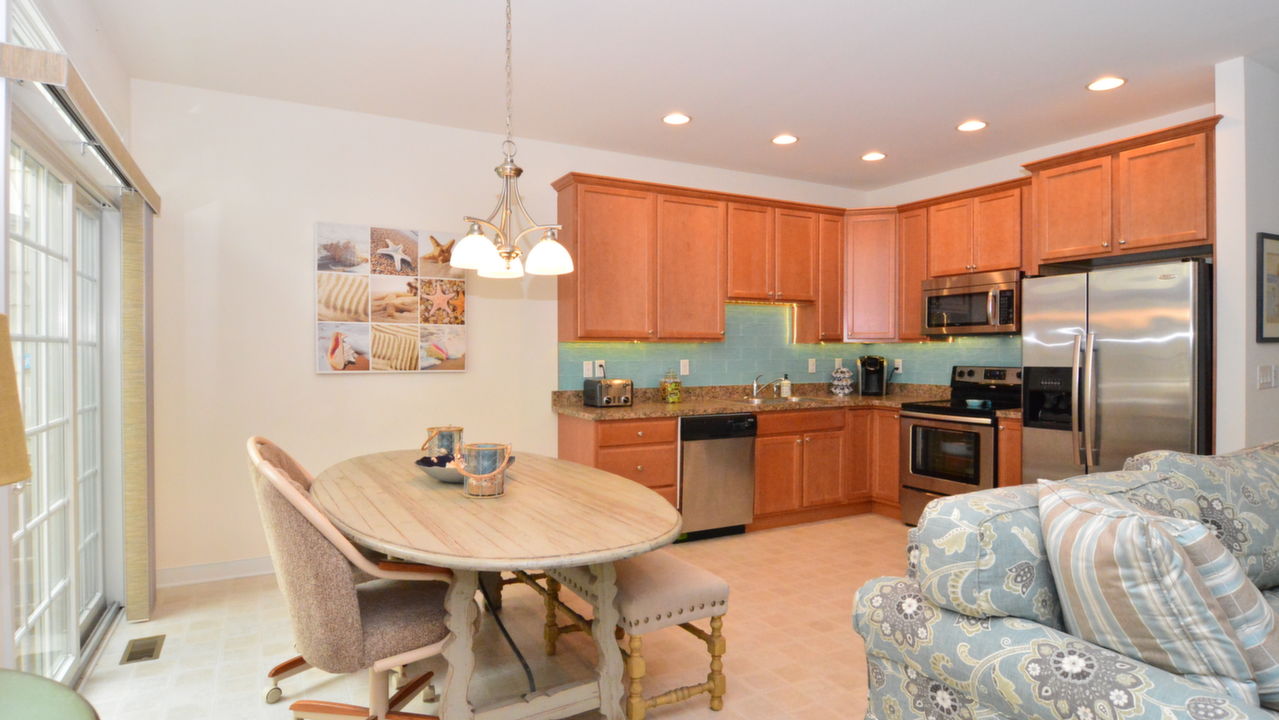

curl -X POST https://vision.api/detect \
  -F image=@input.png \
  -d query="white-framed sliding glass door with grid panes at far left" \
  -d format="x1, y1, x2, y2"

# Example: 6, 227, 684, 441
6, 143, 105, 680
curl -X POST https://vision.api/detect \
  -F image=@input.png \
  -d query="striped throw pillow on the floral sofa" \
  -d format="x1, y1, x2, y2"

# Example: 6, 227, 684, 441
1040, 481, 1265, 706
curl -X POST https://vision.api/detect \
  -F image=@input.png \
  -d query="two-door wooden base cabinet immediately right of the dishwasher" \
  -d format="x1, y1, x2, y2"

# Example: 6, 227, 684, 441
755, 409, 844, 517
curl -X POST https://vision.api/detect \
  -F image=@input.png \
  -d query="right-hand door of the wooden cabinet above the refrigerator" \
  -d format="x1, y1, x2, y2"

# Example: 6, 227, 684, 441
1115, 133, 1210, 251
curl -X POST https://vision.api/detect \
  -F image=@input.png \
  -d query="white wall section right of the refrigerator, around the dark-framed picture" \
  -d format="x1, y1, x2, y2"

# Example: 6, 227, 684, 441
1215, 58, 1279, 450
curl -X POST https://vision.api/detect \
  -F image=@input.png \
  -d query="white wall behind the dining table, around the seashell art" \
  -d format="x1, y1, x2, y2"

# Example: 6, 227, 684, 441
133, 81, 861, 579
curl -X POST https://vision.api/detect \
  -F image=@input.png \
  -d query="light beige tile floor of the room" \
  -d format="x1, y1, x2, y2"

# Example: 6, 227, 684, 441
82, 515, 907, 720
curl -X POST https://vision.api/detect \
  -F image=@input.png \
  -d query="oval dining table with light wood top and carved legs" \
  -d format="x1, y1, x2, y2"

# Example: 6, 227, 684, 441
311, 450, 682, 720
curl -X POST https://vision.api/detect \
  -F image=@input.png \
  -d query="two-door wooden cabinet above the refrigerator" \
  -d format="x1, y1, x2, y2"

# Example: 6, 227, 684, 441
1024, 115, 1220, 267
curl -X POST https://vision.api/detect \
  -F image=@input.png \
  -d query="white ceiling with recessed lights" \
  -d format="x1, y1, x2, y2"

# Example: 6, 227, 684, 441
87, 0, 1279, 189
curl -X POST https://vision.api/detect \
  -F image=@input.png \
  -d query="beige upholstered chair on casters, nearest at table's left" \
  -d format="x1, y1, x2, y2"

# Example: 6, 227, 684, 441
248, 437, 451, 720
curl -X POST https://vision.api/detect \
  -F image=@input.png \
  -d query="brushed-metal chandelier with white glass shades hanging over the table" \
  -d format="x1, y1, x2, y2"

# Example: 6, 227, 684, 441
450, 0, 573, 278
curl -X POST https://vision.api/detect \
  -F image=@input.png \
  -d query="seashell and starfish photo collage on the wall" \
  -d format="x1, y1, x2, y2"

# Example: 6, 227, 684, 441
315, 223, 467, 373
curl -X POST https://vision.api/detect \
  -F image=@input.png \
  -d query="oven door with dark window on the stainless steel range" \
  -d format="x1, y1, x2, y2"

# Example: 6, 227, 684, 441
900, 412, 996, 495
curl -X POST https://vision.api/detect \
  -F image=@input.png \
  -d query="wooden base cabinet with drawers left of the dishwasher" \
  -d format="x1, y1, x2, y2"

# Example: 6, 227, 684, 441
559, 416, 679, 508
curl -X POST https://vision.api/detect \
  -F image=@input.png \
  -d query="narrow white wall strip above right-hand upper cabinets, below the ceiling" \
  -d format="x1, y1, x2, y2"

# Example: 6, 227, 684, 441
865, 105, 1215, 206
